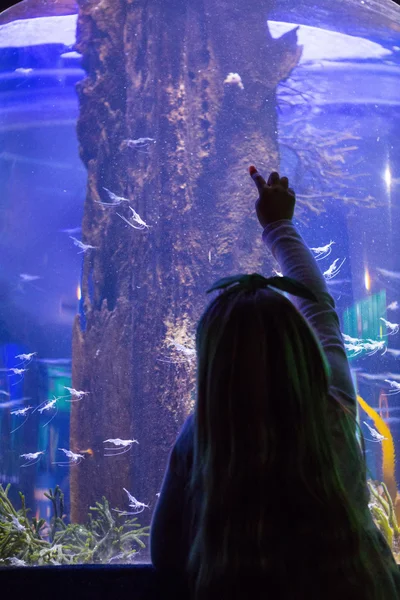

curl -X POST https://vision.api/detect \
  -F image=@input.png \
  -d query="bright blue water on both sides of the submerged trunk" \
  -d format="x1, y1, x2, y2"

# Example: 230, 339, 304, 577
0, 0, 400, 564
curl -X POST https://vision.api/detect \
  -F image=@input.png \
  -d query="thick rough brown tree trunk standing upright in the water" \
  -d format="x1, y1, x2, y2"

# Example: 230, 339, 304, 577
71, 0, 301, 524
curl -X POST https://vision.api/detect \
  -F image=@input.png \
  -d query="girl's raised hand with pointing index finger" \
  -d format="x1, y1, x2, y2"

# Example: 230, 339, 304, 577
249, 166, 296, 228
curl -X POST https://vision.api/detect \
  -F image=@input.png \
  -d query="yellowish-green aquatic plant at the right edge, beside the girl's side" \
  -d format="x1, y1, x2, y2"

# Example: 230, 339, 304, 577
367, 480, 400, 562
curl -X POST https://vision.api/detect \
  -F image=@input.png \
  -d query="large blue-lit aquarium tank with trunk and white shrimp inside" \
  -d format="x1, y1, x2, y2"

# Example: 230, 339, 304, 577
0, 0, 400, 568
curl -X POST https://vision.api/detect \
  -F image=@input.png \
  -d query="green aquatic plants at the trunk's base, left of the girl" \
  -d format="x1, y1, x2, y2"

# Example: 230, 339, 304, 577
0, 485, 150, 566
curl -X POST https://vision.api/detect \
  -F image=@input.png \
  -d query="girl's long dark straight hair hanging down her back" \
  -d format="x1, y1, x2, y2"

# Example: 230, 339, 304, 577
187, 286, 395, 600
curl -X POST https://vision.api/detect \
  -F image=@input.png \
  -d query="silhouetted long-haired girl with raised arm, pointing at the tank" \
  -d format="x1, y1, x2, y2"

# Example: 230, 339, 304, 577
151, 167, 400, 600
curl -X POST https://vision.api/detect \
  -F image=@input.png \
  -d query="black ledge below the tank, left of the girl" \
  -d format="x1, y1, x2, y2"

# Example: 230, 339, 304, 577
0, 564, 188, 600
